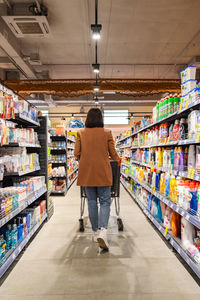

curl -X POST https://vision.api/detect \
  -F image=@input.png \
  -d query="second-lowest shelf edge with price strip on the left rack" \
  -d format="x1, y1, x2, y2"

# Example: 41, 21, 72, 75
0, 187, 46, 227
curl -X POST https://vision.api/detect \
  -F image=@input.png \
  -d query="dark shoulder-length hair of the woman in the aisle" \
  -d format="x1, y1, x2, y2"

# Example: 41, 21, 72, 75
85, 108, 104, 128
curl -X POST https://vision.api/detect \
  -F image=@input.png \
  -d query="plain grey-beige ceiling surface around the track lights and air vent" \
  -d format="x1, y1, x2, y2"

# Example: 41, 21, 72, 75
0, 0, 200, 106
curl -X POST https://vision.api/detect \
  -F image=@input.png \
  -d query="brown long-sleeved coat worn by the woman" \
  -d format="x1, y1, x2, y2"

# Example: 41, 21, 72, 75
74, 128, 120, 186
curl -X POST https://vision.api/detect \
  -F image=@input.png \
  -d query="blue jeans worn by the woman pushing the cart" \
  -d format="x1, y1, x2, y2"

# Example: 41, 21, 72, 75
85, 186, 111, 231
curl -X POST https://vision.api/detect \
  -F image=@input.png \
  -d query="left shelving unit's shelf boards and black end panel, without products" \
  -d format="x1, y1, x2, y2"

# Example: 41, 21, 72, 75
0, 114, 48, 277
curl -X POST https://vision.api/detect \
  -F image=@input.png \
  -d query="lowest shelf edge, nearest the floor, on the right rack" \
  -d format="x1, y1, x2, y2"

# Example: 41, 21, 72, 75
121, 179, 200, 278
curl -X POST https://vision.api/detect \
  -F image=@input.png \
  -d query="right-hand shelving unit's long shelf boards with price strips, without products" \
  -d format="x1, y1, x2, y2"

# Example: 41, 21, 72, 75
117, 95, 200, 278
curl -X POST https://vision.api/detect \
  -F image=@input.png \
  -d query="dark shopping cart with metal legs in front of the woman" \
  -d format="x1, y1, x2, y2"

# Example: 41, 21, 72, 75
79, 161, 124, 232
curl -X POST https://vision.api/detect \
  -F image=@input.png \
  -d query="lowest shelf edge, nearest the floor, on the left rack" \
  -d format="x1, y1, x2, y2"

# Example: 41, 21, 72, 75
0, 213, 47, 277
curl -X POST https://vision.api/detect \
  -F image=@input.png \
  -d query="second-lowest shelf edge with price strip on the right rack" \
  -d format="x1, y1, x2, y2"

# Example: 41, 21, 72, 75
121, 173, 200, 229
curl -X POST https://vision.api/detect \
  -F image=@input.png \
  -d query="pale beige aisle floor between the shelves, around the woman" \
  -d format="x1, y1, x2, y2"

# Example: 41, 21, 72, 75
0, 185, 200, 300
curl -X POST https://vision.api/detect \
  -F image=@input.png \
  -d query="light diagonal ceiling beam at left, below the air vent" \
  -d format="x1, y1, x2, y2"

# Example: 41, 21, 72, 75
0, 18, 37, 79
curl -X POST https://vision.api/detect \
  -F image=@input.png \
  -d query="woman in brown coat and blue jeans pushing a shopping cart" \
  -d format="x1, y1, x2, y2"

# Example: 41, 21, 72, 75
74, 108, 120, 250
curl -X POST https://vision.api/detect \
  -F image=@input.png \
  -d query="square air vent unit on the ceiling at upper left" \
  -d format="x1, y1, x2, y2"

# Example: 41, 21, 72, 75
2, 16, 50, 38
